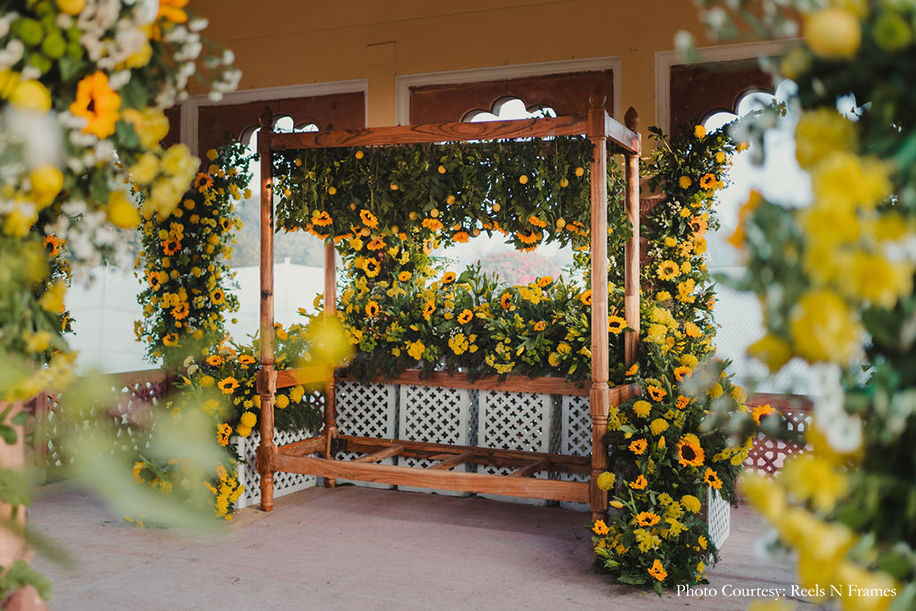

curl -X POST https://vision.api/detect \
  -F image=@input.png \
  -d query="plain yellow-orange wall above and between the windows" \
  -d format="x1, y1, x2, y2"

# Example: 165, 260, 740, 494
192, 0, 716, 130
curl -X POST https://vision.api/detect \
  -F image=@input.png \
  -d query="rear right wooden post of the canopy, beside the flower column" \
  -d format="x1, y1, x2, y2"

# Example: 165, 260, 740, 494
623, 106, 640, 367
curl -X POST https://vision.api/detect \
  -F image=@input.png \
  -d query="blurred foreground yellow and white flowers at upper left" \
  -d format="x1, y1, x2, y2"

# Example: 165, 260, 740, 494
0, 0, 239, 399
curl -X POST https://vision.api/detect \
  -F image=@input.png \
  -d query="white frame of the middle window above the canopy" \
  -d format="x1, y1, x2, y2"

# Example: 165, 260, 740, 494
395, 56, 622, 125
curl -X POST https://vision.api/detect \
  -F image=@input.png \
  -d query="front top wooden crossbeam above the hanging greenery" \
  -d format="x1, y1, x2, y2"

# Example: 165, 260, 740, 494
270, 116, 586, 150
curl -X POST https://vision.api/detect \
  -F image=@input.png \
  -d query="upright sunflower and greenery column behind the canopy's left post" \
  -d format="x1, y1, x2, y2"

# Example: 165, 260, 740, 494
134, 142, 251, 366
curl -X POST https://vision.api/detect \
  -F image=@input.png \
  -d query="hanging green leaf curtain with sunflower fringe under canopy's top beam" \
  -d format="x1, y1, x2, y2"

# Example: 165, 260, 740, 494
274, 137, 592, 250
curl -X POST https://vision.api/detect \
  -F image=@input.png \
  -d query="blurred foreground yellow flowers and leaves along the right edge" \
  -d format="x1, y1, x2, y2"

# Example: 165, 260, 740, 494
696, 1, 916, 609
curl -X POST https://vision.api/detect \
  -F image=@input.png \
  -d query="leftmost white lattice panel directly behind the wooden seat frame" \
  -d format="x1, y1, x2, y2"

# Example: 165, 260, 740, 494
335, 380, 398, 488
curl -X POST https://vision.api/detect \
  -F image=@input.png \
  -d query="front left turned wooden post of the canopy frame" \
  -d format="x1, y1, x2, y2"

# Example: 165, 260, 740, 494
257, 107, 277, 511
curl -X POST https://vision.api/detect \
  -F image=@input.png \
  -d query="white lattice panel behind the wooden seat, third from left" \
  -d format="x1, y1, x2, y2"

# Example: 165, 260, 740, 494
477, 390, 556, 505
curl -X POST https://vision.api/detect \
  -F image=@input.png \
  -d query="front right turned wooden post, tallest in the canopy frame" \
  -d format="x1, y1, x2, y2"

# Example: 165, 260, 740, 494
588, 88, 610, 520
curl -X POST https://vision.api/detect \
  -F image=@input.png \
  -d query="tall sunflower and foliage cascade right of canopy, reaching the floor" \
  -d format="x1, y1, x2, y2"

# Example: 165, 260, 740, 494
589, 126, 763, 594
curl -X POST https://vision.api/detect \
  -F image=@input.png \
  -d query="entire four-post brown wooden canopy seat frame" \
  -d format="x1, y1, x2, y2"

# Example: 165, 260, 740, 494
257, 90, 641, 519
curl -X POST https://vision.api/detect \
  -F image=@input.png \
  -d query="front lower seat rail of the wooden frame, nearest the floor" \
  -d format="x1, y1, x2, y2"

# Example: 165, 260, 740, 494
272, 454, 588, 503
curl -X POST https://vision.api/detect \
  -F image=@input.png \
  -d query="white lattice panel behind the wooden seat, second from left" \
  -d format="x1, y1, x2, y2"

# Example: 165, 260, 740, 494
397, 386, 471, 496
